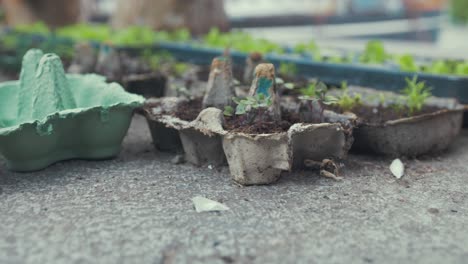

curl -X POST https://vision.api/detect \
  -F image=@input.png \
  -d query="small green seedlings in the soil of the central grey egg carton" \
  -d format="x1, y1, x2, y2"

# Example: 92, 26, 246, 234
224, 94, 273, 116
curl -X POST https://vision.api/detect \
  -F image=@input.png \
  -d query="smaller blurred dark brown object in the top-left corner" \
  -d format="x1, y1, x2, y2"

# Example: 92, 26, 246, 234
2, 0, 80, 27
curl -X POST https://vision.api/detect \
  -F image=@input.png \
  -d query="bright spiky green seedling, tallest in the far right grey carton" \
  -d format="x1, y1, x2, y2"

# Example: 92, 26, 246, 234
402, 76, 432, 115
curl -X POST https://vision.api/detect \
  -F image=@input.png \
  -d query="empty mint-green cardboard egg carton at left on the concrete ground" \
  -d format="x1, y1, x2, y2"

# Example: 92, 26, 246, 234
0, 50, 144, 172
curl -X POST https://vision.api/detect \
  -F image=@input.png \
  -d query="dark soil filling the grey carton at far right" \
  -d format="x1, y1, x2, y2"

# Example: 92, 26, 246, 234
329, 105, 442, 124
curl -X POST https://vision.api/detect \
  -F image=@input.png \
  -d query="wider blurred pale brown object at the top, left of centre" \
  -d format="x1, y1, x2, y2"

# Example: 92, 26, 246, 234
112, 0, 229, 35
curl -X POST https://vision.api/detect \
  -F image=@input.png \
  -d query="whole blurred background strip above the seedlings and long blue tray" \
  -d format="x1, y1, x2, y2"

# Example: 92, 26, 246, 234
0, 0, 468, 58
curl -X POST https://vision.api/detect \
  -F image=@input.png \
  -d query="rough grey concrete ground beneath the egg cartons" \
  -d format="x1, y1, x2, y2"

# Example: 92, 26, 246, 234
0, 116, 468, 264
